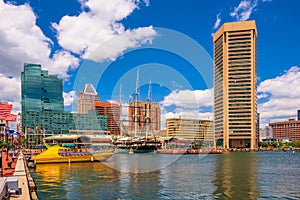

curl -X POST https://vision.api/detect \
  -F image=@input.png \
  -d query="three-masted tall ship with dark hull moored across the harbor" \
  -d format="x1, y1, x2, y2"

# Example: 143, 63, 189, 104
114, 71, 162, 153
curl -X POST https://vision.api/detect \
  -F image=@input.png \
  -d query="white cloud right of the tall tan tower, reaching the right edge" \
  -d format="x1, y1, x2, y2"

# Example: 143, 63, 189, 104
258, 66, 300, 127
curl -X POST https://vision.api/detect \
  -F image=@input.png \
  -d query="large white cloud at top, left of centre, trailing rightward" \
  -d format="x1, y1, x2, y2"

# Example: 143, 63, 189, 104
52, 0, 156, 61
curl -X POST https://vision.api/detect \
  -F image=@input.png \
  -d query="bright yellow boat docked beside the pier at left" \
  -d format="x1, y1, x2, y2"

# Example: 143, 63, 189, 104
30, 145, 113, 164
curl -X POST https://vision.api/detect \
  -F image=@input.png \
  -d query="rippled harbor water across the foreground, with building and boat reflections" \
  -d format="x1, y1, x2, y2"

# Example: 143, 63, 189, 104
31, 152, 300, 200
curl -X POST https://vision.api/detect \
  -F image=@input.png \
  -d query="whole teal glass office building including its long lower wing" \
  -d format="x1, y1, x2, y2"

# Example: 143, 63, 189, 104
21, 64, 107, 140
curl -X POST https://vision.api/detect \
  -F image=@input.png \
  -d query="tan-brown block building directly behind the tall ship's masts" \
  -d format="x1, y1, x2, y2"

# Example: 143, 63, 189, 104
129, 101, 160, 132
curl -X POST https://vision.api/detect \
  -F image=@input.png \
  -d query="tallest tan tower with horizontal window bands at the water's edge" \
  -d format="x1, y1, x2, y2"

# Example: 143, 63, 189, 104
213, 21, 257, 149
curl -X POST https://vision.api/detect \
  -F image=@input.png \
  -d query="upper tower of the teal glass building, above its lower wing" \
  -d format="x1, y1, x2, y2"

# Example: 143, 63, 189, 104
21, 63, 64, 132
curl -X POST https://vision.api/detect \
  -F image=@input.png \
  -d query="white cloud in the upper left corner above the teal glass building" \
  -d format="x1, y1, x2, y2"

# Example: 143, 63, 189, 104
0, 0, 79, 78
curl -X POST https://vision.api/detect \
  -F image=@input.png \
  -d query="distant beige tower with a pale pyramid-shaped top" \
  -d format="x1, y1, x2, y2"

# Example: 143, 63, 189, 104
77, 84, 100, 114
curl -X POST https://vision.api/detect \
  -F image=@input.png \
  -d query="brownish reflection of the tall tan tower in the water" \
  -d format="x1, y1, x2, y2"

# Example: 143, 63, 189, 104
213, 152, 259, 199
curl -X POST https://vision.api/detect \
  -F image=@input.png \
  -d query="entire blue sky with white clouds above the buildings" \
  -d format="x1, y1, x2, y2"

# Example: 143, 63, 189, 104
0, 0, 300, 126
